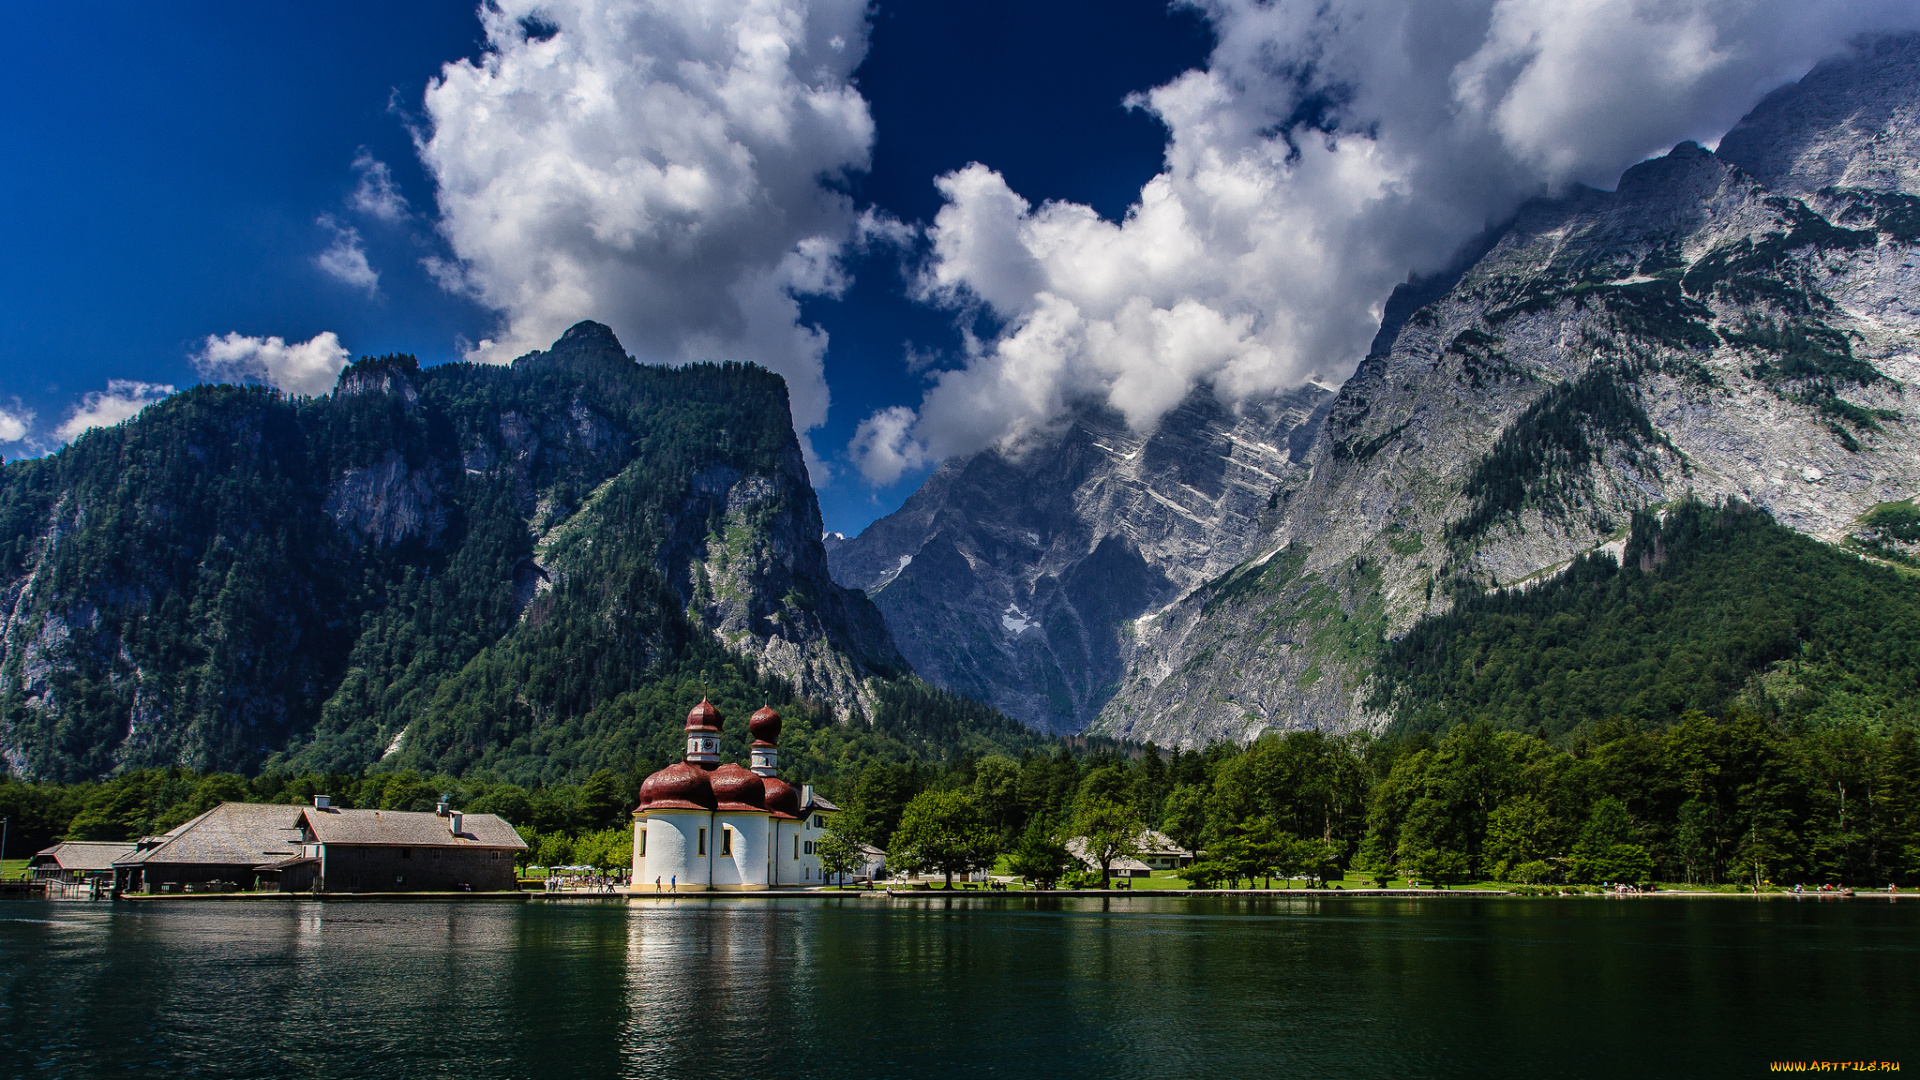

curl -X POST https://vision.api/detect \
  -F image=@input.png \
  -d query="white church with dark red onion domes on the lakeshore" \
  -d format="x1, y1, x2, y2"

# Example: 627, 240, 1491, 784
634, 698, 839, 894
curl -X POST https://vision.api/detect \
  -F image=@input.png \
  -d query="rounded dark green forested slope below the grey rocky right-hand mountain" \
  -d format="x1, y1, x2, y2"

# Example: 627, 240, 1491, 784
1371, 502, 1920, 738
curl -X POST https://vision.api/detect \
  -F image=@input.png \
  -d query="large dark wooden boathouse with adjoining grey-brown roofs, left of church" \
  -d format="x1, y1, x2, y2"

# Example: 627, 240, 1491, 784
113, 796, 526, 894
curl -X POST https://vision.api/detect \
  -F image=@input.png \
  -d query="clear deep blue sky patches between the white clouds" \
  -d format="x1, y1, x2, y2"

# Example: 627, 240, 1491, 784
0, 0, 1208, 530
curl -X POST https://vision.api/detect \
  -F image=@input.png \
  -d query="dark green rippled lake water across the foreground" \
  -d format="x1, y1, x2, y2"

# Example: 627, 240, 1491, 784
0, 897, 1920, 1080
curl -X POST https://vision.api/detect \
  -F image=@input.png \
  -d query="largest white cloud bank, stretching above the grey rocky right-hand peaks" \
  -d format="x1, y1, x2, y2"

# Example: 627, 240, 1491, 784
849, 0, 1920, 484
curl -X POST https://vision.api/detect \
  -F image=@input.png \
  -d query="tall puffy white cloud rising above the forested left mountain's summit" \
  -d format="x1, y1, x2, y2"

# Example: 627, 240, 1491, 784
419, 0, 874, 445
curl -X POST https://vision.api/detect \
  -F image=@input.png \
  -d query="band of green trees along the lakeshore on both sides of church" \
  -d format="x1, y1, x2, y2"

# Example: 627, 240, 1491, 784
15, 707, 1920, 886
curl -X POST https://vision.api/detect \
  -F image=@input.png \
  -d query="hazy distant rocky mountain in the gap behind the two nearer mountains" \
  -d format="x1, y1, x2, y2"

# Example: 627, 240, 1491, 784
828, 386, 1332, 732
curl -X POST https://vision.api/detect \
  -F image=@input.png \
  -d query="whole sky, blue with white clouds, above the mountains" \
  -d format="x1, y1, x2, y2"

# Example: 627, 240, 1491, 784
0, 0, 1920, 534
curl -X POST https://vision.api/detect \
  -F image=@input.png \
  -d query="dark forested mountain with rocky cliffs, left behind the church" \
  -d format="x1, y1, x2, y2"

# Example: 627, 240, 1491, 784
0, 315, 906, 780
